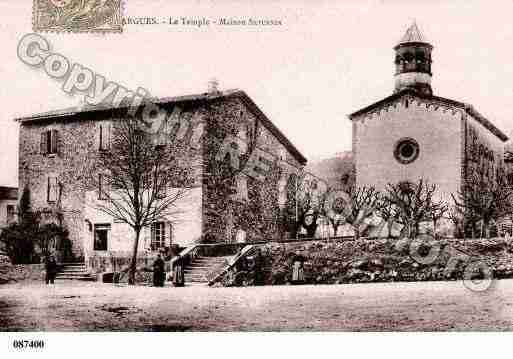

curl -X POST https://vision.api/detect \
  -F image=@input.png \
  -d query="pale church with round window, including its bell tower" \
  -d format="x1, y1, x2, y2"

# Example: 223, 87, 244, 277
349, 23, 508, 203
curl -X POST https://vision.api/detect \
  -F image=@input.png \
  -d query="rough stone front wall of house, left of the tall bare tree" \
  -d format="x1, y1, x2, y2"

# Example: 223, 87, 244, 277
19, 114, 102, 257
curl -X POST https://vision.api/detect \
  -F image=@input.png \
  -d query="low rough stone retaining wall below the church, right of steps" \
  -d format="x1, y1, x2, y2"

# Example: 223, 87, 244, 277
215, 238, 513, 286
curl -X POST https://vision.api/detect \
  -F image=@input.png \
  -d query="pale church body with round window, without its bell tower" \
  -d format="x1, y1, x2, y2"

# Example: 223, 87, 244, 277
352, 91, 505, 203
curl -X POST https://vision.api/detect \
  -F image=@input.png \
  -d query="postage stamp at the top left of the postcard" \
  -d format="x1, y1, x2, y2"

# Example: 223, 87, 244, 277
32, 0, 123, 33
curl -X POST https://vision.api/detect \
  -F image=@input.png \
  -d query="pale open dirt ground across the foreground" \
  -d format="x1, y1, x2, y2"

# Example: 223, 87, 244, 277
0, 279, 513, 331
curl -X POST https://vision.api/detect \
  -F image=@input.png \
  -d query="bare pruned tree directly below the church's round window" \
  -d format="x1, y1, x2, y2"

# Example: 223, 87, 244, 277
385, 179, 444, 238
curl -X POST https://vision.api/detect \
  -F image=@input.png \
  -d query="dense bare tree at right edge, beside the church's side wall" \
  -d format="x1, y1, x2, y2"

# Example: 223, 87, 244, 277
452, 167, 512, 237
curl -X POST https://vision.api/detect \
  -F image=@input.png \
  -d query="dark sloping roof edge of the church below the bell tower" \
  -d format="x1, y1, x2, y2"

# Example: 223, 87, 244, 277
349, 89, 509, 142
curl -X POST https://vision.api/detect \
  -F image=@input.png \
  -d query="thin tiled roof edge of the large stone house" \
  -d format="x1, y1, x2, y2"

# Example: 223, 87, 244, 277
16, 89, 307, 165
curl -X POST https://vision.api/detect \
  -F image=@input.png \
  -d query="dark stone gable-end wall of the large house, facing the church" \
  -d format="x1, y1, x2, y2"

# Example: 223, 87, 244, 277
203, 99, 300, 242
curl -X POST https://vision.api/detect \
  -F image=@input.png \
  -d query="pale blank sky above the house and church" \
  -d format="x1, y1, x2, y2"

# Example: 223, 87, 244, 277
0, 0, 513, 186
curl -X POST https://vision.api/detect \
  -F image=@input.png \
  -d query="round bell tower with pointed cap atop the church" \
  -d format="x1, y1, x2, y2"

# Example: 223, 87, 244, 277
394, 22, 433, 95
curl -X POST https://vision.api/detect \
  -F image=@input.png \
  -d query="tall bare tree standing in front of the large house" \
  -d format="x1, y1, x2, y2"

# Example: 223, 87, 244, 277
91, 118, 196, 284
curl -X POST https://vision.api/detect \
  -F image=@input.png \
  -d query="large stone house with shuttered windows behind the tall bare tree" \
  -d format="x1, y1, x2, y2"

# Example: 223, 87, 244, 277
19, 89, 306, 259
